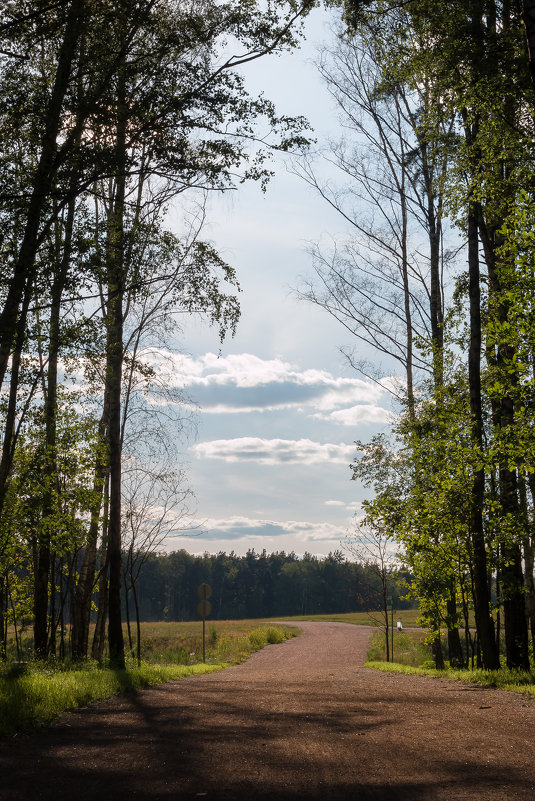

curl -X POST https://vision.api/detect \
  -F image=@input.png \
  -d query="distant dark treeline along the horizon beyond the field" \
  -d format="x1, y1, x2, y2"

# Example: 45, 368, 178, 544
129, 550, 410, 620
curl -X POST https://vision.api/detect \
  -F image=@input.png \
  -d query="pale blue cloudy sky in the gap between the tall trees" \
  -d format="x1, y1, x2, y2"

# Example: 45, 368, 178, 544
166, 10, 398, 557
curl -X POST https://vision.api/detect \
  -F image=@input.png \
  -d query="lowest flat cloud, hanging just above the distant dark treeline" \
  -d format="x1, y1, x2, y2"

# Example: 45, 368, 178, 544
179, 515, 347, 543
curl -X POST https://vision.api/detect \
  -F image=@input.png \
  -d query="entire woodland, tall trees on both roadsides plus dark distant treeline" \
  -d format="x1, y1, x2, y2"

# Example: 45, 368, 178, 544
0, 0, 535, 670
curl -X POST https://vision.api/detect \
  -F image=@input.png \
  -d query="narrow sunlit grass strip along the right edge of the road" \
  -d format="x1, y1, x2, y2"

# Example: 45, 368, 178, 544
365, 662, 535, 697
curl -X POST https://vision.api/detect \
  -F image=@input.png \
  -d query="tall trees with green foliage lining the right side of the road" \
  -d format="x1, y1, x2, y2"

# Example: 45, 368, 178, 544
302, 0, 535, 669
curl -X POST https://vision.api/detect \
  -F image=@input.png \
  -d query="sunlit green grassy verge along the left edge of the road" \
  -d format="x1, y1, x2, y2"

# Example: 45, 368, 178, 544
0, 625, 298, 736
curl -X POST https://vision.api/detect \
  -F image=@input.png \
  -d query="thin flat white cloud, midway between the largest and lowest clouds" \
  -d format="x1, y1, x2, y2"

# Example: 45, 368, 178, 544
192, 437, 355, 465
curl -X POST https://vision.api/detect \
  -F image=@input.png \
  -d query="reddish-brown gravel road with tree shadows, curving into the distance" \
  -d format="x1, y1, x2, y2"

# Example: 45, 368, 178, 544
0, 623, 535, 801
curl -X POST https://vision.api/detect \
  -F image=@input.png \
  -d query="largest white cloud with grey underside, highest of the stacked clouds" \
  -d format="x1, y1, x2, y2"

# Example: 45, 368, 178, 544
147, 350, 386, 416
